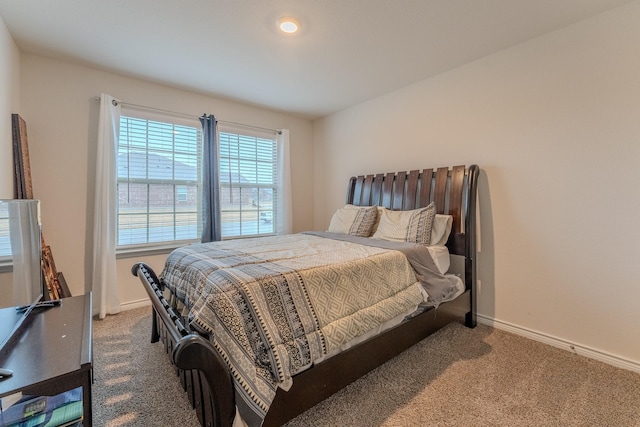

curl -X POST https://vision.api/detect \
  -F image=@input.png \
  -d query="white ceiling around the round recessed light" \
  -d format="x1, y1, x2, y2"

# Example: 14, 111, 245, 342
0, 0, 630, 118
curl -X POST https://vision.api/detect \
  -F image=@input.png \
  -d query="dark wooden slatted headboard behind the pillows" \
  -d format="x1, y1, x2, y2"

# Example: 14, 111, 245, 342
347, 165, 479, 289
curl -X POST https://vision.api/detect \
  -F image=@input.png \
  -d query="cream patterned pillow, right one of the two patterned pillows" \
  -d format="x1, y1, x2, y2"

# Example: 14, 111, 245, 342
371, 202, 436, 246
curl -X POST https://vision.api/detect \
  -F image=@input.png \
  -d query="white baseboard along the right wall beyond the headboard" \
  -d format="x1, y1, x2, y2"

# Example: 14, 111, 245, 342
478, 314, 640, 373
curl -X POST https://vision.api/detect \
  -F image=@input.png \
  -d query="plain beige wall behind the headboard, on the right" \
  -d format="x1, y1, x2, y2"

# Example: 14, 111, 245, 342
314, 2, 640, 367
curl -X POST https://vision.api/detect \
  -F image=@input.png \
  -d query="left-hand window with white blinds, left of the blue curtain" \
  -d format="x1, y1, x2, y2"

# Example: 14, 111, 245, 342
117, 111, 202, 250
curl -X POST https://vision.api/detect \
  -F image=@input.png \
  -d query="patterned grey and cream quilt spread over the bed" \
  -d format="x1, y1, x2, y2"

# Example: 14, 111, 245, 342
162, 234, 424, 426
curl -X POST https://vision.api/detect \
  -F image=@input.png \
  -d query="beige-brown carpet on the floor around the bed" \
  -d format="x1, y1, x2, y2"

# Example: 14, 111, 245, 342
93, 308, 640, 427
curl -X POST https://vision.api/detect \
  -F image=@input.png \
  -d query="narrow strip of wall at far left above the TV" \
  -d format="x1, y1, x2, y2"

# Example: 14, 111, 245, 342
0, 17, 20, 199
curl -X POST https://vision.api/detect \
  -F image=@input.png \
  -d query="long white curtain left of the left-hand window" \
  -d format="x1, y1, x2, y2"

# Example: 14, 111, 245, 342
93, 94, 120, 319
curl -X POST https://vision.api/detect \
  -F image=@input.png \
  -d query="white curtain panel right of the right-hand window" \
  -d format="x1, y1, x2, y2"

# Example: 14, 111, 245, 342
276, 129, 293, 234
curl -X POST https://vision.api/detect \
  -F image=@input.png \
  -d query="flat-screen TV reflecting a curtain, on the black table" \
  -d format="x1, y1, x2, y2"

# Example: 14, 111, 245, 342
0, 199, 44, 356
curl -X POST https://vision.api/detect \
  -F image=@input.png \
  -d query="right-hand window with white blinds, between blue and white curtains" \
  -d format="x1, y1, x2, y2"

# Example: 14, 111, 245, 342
218, 126, 278, 238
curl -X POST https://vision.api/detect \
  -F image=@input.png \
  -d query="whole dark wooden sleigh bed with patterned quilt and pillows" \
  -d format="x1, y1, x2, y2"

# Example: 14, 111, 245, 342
132, 165, 479, 427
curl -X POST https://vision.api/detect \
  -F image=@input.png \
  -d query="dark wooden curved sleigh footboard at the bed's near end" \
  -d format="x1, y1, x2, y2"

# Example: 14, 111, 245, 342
131, 263, 235, 427
